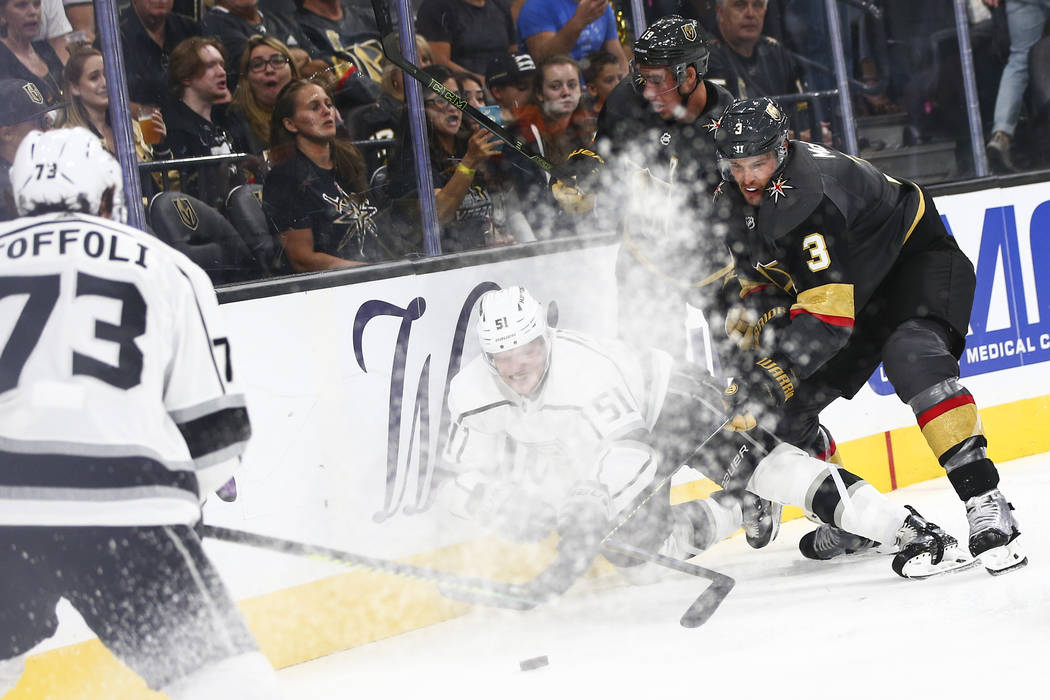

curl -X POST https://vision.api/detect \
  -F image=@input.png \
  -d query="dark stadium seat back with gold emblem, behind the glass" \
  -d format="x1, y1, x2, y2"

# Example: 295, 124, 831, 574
149, 192, 259, 284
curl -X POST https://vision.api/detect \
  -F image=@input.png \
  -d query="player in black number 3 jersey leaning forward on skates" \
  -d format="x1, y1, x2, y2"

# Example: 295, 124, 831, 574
714, 98, 1027, 574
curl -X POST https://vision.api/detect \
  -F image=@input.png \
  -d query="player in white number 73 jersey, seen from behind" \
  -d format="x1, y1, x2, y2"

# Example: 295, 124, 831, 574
0, 128, 279, 700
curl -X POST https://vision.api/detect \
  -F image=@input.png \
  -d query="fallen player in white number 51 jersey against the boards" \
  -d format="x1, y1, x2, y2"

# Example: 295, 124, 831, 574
444, 287, 972, 578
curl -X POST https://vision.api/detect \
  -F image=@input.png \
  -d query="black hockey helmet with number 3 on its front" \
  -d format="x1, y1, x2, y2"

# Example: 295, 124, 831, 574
714, 98, 788, 179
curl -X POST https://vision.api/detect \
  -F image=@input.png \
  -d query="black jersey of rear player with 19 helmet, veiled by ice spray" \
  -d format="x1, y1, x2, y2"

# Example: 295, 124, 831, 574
595, 77, 733, 357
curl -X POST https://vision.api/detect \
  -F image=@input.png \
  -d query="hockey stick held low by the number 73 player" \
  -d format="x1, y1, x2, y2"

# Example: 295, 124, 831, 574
200, 525, 540, 610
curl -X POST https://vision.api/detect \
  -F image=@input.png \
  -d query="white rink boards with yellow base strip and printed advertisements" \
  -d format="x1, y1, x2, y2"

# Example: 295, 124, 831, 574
6, 179, 1050, 700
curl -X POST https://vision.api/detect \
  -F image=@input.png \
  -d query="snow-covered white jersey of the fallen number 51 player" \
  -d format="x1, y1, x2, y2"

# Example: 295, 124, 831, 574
443, 330, 671, 512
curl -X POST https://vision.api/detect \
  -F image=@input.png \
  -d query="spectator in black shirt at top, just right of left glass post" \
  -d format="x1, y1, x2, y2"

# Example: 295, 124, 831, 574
121, 0, 203, 112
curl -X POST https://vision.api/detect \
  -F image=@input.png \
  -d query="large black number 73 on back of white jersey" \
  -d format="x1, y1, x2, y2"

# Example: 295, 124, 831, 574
0, 272, 146, 393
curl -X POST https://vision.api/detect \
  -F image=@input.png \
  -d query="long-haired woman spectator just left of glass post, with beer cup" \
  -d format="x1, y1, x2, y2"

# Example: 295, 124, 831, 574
61, 44, 170, 161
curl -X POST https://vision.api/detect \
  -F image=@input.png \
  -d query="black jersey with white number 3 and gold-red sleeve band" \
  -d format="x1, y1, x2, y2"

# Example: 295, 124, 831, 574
718, 141, 932, 378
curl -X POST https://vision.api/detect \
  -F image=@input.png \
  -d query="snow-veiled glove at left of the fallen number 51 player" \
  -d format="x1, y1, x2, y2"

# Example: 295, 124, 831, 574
466, 481, 558, 542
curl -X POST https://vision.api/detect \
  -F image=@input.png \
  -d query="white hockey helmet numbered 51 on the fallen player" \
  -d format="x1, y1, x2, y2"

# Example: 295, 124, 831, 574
478, 285, 548, 356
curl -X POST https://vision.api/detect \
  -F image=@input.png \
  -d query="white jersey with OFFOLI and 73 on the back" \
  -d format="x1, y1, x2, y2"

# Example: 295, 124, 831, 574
0, 214, 251, 526
